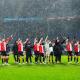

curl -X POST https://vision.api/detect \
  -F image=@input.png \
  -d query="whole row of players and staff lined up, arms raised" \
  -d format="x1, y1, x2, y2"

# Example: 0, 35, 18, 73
0, 36, 80, 64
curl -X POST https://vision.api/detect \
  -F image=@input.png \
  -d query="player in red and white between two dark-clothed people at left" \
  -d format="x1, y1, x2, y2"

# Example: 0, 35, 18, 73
17, 39, 24, 64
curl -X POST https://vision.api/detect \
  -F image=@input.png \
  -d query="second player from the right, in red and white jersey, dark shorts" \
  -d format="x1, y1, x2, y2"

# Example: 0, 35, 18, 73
66, 40, 72, 63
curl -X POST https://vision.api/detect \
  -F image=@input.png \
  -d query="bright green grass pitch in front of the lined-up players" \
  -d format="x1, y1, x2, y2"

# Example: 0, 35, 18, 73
0, 55, 80, 80
